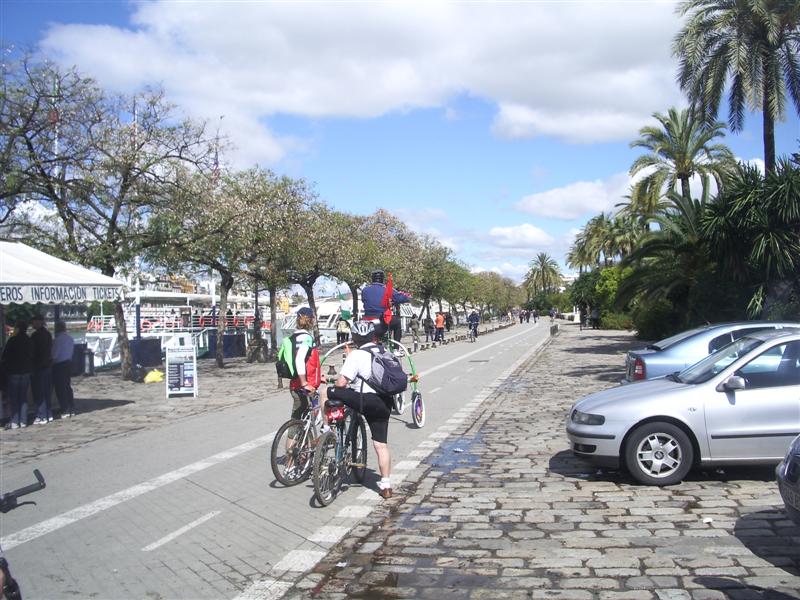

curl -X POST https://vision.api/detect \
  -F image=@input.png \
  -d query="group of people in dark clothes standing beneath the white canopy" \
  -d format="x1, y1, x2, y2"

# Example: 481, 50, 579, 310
0, 314, 75, 429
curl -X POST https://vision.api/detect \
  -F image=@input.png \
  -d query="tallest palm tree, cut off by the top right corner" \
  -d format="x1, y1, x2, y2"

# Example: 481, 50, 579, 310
672, 0, 800, 172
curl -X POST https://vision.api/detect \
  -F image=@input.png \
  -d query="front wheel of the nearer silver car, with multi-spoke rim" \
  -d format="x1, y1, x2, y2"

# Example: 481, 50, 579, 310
625, 422, 694, 485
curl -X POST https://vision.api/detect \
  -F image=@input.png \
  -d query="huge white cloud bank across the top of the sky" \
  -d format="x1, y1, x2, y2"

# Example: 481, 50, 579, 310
42, 0, 680, 164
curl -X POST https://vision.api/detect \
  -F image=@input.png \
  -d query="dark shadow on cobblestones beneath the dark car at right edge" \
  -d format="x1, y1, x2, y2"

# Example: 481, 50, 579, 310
733, 508, 800, 576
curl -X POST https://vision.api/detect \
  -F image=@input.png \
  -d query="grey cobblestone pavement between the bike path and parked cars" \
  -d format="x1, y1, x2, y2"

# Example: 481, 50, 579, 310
284, 325, 800, 600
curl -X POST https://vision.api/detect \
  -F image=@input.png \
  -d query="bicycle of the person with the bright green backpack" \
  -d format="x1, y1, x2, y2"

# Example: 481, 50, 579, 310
270, 392, 320, 487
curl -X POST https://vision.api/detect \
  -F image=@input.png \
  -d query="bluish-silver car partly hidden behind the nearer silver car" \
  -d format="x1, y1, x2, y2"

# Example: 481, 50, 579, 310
622, 321, 800, 383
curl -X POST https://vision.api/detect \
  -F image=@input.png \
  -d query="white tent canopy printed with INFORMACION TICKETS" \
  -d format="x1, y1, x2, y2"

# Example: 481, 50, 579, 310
0, 241, 122, 304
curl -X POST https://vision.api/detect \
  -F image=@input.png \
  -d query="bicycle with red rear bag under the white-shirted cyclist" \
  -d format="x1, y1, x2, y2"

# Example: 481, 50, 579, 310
313, 400, 367, 506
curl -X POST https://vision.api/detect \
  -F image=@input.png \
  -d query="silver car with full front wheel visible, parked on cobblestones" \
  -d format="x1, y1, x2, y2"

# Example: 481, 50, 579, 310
566, 330, 800, 485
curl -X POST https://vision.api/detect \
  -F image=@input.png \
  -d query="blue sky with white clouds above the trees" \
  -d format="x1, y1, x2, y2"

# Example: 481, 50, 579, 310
0, 0, 800, 281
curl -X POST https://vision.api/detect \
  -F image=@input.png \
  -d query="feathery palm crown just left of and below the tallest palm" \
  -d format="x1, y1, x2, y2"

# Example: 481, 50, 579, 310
629, 108, 735, 215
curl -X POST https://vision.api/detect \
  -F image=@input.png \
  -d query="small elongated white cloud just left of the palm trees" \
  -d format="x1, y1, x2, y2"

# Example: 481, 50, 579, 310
514, 173, 631, 220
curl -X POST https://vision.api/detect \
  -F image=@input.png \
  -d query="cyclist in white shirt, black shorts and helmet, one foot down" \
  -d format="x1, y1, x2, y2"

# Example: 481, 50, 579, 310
321, 321, 392, 498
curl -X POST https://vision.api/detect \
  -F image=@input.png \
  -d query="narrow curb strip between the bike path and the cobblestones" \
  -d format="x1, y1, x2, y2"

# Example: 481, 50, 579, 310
262, 330, 557, 600
